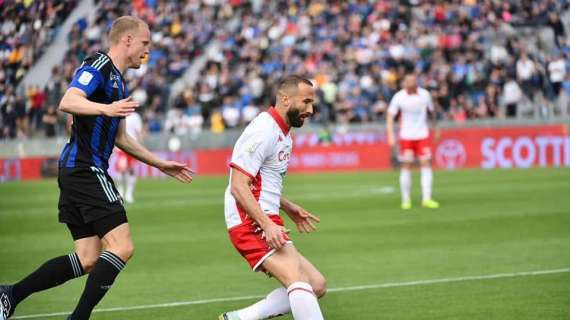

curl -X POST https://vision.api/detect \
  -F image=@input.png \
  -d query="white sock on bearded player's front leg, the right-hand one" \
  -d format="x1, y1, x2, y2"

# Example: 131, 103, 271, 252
287, 282, 324, 320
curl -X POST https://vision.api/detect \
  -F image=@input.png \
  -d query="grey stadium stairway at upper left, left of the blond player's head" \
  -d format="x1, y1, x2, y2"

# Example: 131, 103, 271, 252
18, 0, 97, 92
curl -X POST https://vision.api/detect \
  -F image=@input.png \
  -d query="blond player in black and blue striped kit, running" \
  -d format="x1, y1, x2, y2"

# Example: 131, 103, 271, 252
0, 16, 192, 320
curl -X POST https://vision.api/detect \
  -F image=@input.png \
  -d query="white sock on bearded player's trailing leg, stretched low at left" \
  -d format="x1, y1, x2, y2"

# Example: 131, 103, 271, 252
237, 288, 291, 320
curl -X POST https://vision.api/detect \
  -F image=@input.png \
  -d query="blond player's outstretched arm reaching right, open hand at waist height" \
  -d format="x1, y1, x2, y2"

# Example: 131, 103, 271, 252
115, 120, 193, 182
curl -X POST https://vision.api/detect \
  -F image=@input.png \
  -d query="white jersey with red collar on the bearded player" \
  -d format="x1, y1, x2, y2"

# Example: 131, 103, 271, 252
224, 108, 293, 229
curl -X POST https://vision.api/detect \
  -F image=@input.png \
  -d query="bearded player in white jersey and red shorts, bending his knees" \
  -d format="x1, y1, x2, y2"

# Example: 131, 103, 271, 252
219, 76, 326, 320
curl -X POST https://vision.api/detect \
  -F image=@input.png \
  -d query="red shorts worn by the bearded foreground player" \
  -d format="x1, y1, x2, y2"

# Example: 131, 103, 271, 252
228, 214, 290, 271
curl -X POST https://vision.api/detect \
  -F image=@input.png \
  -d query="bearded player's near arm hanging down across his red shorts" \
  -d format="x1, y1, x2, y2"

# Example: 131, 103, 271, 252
230, 168, 287, 249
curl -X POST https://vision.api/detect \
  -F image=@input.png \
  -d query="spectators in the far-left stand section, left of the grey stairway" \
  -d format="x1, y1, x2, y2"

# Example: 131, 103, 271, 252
0, 0, 76, 137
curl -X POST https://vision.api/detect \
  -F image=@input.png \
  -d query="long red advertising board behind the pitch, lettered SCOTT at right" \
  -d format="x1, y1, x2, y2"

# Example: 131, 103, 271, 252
0, 125, 570, 181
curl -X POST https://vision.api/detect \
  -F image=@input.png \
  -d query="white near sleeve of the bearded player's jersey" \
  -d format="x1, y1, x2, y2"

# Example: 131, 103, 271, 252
230, 127, 274, 179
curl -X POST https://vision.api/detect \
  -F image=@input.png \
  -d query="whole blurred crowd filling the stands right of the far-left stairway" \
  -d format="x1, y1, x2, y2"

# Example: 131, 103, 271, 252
0, 0, 570, 137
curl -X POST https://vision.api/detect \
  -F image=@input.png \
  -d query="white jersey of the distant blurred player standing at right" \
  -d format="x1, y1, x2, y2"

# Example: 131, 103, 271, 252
388, 87, 433, 140
